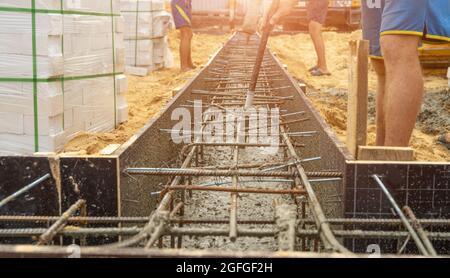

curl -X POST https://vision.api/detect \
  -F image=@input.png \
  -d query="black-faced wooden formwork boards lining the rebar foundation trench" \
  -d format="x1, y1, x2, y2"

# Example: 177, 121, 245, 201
0, 34, 450, 257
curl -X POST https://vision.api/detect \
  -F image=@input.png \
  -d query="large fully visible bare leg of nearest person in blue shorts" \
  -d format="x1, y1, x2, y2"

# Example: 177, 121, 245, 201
381, 35, 424, 147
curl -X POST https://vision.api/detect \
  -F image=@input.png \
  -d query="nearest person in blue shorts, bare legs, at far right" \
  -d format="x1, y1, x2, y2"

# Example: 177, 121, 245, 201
270, 0, 450, 150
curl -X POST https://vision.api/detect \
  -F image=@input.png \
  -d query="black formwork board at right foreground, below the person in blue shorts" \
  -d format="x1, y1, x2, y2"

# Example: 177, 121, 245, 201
345, 162, 450, 254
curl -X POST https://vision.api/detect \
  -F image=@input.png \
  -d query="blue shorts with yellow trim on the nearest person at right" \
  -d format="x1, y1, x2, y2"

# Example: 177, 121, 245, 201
362, 0, 450, 58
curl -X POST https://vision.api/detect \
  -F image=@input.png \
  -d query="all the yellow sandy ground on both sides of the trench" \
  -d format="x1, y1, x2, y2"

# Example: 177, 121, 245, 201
64, 31, 450, 161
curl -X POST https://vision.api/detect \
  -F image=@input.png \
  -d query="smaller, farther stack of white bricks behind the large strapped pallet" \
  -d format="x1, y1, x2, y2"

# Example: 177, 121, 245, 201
120, 0, 173, 76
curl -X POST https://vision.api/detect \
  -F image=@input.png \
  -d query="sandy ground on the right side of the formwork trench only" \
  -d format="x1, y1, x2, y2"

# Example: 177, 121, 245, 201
270, 31, 450, 161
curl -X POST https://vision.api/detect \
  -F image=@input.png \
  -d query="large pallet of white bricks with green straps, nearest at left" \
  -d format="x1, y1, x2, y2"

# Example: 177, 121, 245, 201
0, 0, 128, 155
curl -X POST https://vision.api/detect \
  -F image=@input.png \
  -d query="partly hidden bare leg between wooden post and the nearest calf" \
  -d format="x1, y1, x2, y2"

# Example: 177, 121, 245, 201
371, 59, 386, 146
